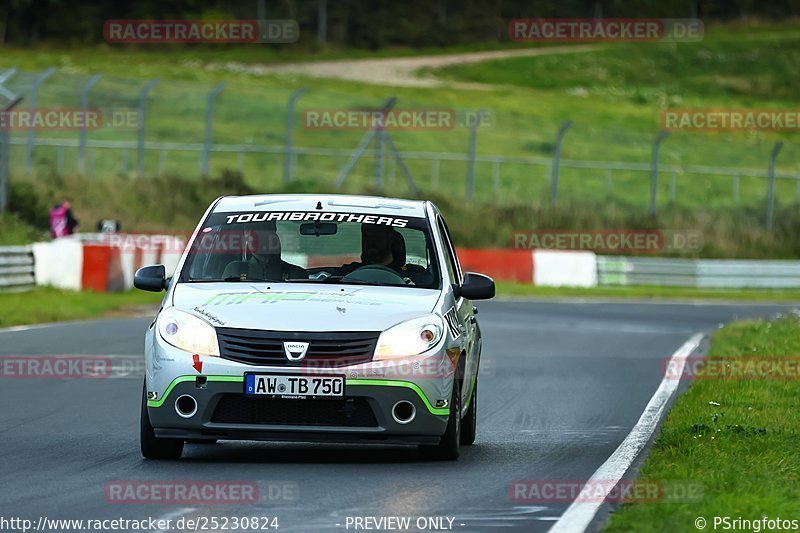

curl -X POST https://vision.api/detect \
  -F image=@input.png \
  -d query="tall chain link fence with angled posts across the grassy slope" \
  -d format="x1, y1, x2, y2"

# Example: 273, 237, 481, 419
0, 69, 800, 223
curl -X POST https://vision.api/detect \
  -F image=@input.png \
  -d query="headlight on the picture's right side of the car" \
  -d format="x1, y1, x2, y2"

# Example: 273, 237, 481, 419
373, 314, 444, 361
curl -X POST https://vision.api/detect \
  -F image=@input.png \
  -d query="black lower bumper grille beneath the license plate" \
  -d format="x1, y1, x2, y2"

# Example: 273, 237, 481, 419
211, 394, 378, 427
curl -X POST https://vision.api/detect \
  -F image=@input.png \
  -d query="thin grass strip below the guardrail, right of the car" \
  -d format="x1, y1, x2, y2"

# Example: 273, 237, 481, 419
497, 281, 800, 302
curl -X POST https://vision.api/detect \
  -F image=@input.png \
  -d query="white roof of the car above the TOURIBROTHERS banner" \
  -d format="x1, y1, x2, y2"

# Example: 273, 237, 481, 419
213, 194, 425, 217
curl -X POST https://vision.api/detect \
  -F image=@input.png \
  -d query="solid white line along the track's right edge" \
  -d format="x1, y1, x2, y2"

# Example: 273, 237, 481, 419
550, 333, 703, 533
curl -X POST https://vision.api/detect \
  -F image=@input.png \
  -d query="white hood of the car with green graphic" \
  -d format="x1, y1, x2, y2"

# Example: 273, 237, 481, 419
172, 282, 439, 331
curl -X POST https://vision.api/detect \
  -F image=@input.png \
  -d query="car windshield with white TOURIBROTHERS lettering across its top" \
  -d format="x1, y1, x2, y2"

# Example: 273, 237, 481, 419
179, 211, 441, 289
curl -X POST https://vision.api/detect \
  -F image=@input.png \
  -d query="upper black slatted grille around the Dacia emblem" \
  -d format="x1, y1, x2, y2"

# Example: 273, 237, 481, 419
217, 328, 380, 368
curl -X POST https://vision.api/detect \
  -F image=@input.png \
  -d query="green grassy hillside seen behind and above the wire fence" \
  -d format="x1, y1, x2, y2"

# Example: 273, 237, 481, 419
2, 25, 800, 214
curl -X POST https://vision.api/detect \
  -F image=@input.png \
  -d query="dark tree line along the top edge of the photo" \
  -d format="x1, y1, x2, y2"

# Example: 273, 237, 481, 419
0, 0, 800, 50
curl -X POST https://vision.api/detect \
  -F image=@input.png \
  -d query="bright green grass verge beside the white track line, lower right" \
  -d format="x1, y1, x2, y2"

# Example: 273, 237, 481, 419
606, 316, 800, 531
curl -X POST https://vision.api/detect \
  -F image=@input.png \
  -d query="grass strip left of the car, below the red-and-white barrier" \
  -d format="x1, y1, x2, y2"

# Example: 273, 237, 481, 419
0, 287, 164, 327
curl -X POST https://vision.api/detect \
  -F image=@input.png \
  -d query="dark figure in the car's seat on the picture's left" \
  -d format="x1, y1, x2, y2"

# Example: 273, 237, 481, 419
222, 223, 308, 280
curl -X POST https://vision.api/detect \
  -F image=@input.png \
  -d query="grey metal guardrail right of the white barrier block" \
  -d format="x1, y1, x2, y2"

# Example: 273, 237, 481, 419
597, 256, 800, 289
